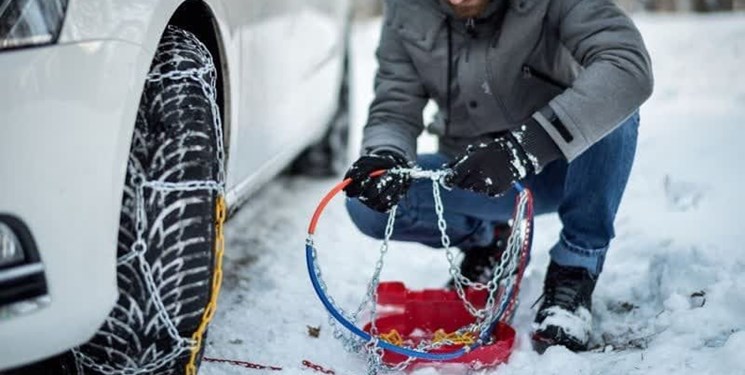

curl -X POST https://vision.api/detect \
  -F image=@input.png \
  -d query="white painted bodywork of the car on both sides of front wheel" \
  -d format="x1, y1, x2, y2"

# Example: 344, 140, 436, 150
0, 0, 349, 370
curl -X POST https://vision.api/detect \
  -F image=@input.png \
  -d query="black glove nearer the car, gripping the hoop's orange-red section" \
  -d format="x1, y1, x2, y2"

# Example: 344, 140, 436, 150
344, 151, 411, 212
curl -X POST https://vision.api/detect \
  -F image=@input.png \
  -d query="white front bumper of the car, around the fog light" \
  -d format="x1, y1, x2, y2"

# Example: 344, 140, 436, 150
0, 41, 149, 370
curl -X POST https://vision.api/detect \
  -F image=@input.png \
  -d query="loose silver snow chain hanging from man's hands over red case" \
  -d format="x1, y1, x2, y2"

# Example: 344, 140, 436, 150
306, 168, 532, 375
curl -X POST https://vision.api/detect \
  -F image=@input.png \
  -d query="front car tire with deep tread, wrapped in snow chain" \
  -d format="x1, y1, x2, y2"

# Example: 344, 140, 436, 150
73, 26, 226, 375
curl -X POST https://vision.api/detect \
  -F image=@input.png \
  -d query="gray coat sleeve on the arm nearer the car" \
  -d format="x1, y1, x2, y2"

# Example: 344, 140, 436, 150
362, 0, 428, 161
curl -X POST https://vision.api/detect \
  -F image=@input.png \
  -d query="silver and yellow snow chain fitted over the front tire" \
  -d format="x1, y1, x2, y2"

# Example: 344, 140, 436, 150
73, 47, 226, 375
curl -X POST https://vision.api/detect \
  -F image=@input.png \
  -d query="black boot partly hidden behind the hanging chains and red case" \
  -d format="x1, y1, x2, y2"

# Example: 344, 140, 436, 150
447, 224, 512, 289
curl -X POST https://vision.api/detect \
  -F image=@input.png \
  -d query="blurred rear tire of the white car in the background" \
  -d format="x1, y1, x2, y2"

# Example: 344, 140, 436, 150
289, 53, 351, 177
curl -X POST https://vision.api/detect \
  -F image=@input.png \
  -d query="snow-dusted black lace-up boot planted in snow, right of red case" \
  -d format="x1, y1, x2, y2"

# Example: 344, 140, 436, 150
533, 261, 597, 353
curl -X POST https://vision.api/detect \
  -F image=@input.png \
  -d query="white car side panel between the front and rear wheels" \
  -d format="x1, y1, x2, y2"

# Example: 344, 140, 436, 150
223, 0, 347, 193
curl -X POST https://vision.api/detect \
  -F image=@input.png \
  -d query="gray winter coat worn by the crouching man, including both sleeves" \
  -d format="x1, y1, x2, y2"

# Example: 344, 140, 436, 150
362, 0, 652, 161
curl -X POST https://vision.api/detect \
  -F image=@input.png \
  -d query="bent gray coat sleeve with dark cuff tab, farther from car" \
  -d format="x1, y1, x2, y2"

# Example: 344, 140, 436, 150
534, 0, 653, 161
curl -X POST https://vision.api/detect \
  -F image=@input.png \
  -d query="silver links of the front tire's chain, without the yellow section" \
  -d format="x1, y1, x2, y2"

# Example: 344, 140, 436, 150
73, 44, 225, 375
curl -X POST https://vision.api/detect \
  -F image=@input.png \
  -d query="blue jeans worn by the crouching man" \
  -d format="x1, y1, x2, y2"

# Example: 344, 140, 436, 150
347, 113, 639, 275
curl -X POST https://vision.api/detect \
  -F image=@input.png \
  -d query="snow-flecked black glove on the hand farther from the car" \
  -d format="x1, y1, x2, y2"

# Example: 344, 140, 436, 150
447, 118, 562, 197
